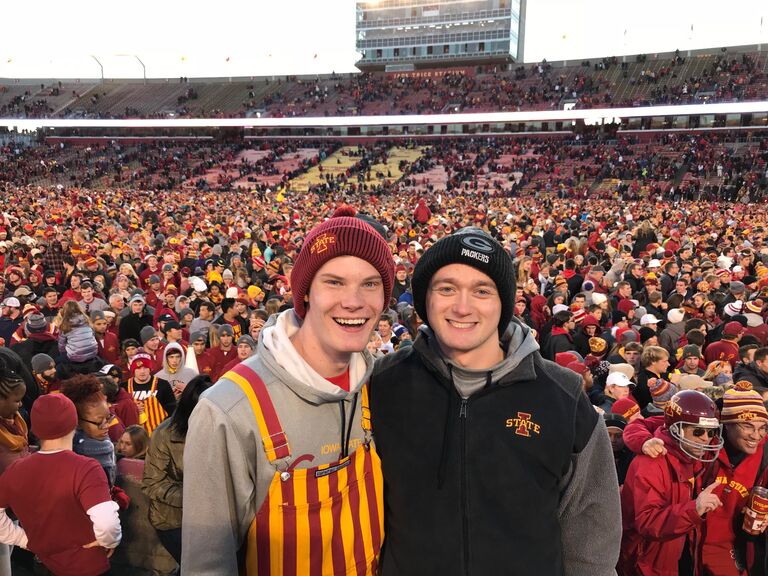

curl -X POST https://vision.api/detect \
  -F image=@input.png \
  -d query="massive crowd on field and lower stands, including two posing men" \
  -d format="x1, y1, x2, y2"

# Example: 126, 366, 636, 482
0, 124, 768, 576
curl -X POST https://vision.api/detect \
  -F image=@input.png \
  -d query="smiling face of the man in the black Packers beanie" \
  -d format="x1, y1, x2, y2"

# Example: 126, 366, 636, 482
427, 264, 503, 369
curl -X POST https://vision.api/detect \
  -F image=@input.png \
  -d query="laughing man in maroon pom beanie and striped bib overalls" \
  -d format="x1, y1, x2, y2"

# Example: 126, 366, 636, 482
181, 209, 394, 576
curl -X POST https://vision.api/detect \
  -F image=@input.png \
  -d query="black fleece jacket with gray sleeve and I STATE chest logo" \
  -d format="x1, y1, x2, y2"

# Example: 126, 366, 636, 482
370, 331, 621, 576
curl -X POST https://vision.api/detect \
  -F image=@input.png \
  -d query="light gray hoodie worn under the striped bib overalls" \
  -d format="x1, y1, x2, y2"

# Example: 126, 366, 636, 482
182, 310, 373, 576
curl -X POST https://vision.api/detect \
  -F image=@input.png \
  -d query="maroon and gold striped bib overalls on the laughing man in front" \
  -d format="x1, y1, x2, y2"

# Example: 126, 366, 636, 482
224, 364, 384, 576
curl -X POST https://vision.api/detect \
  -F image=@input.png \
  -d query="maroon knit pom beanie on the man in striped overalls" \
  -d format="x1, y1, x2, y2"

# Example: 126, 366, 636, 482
291, 206, 395, 319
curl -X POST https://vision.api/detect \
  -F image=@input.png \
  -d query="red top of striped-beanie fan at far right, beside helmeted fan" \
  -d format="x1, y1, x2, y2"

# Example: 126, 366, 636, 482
623, 416, 765, 576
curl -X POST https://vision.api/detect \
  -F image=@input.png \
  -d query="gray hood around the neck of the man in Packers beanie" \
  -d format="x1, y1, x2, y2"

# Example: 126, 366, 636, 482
414, 320, 539, 398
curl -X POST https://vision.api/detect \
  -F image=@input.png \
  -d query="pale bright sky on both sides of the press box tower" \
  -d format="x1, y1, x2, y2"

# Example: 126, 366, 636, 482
0, 0, 768, 78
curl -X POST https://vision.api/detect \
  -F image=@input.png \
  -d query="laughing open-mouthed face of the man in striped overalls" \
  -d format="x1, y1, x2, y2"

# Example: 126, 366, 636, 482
300, 256, 384, 376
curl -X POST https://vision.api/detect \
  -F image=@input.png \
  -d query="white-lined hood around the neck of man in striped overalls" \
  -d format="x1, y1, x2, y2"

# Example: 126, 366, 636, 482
256, 309, 373, 404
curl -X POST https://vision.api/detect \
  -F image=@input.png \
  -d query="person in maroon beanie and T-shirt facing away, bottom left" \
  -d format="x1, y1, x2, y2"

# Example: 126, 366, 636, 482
0, 394, 122, 576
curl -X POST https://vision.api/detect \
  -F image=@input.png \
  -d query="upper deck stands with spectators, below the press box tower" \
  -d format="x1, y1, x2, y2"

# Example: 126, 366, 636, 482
0, 52, 768, 118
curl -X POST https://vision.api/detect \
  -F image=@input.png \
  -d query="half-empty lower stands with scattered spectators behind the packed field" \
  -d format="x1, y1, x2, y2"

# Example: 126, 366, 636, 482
0, 133, 768, 209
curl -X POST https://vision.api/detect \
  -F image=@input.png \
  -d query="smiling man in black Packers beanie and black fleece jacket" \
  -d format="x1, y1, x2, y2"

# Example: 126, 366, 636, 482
371, 227, 621, 576
